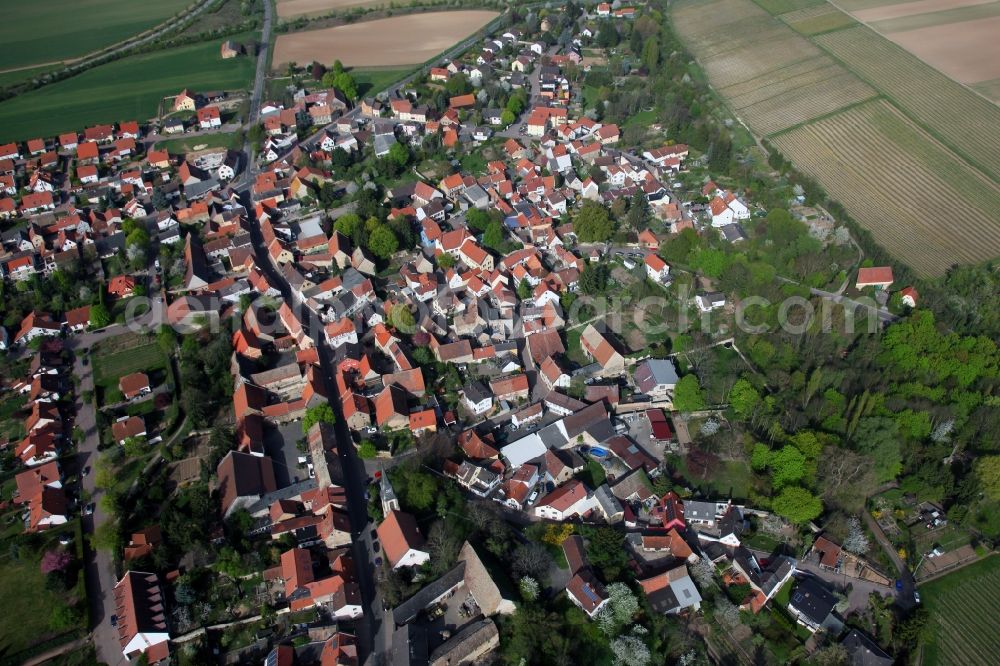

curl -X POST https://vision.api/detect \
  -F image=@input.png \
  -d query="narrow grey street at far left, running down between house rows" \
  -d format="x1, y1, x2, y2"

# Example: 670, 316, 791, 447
66, 299, 163, 666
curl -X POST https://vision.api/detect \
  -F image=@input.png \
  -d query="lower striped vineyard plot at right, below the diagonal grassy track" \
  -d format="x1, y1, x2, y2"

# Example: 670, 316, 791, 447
772, 100, 1000, 275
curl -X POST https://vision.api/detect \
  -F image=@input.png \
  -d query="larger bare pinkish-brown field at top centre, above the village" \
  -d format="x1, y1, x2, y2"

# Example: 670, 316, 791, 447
271, 10, 498, 70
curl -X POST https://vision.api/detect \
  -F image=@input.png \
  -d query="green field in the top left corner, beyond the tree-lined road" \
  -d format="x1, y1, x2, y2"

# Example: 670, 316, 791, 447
0, 0, 191, 69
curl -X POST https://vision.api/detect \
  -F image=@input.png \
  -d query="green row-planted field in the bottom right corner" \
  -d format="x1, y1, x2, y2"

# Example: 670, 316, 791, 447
920, 556, 1000, 666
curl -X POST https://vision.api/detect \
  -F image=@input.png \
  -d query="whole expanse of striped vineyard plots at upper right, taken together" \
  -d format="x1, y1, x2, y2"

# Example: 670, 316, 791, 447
672, 0, 1000, 275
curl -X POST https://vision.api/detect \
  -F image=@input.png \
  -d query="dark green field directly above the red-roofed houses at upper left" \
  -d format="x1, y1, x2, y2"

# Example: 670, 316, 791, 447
0, 33, 256, 141
